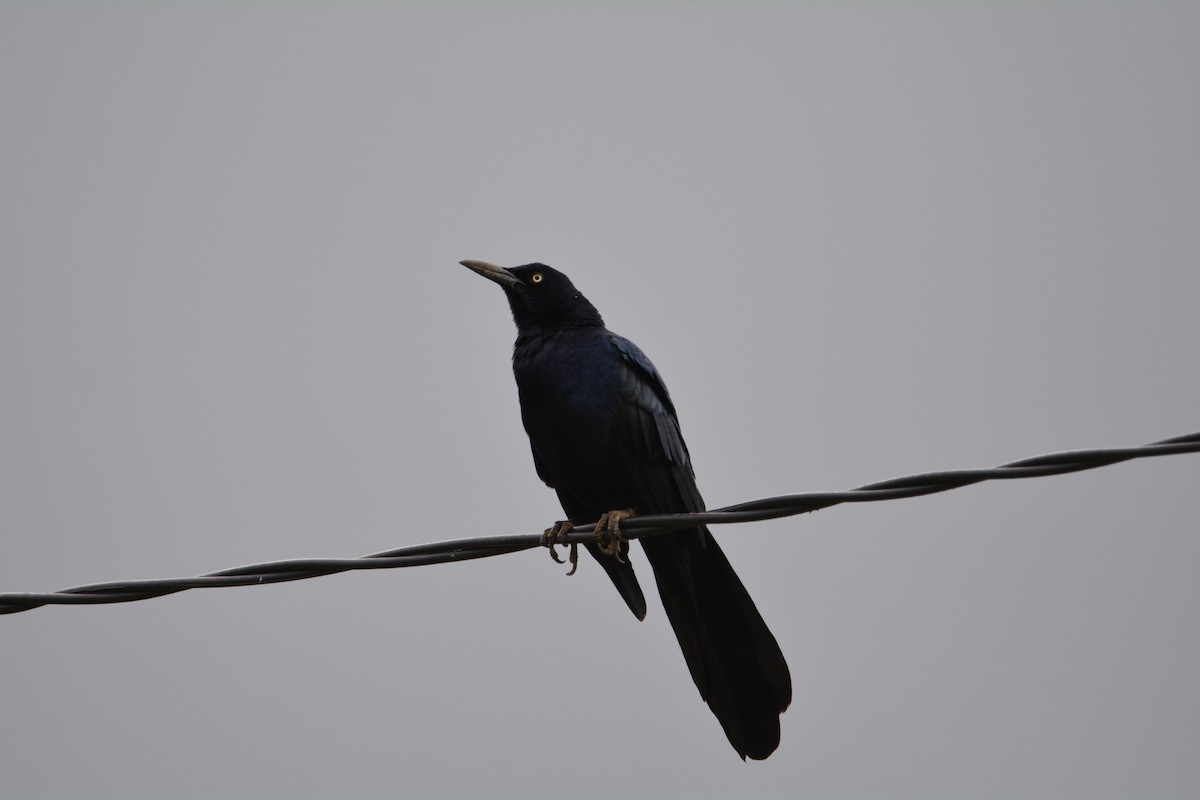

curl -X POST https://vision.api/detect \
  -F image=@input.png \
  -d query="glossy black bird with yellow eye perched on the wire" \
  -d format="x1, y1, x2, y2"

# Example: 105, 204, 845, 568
462, 261, 792, 759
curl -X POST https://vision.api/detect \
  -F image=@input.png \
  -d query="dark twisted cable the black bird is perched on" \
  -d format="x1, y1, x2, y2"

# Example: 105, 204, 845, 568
0, 433, 1200, 614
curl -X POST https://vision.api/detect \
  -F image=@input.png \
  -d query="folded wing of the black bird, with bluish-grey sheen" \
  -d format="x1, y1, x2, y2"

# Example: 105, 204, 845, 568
611, 333, 704, 513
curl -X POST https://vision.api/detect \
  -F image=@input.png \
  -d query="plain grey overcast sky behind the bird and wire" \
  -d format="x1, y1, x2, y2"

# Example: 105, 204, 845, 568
0, 1, 1200, 799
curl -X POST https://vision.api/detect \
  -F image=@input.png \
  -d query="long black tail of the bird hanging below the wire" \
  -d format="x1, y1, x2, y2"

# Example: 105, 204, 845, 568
642, 528, 792, 759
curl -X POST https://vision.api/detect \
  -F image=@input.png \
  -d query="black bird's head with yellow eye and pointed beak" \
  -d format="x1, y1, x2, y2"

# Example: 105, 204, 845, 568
460, 260, 604, 331
